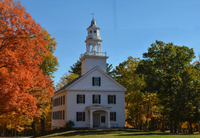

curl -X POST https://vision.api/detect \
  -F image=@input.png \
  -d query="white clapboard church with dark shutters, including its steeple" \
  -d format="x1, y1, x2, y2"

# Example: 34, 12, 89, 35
52, 18, 126, 129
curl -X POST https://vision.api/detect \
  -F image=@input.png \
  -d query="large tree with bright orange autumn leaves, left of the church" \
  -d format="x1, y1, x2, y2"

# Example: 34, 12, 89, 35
0, 0, 54, 132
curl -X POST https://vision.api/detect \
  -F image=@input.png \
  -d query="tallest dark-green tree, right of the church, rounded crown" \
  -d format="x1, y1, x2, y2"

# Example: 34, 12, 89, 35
137, 41, 195, 132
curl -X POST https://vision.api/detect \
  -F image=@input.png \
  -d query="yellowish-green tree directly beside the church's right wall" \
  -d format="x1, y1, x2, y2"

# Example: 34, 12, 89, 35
113, 57, 156, 129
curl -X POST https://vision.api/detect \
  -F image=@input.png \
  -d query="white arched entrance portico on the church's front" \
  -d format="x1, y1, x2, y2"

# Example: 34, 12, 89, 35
86, 105, 112, 128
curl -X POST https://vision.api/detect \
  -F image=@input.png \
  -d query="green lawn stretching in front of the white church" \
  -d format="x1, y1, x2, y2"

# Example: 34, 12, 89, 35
41, 129, 200, 138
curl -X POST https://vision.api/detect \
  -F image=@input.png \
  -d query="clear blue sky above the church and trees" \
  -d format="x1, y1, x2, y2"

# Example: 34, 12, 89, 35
20, 0, 200, 84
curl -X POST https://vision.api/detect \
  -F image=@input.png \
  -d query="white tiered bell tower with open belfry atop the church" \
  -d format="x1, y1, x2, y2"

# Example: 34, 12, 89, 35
80, 18, 108, 75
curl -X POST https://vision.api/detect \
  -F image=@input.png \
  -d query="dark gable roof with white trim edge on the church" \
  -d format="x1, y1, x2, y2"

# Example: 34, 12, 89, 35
55, 66, 127, 93
